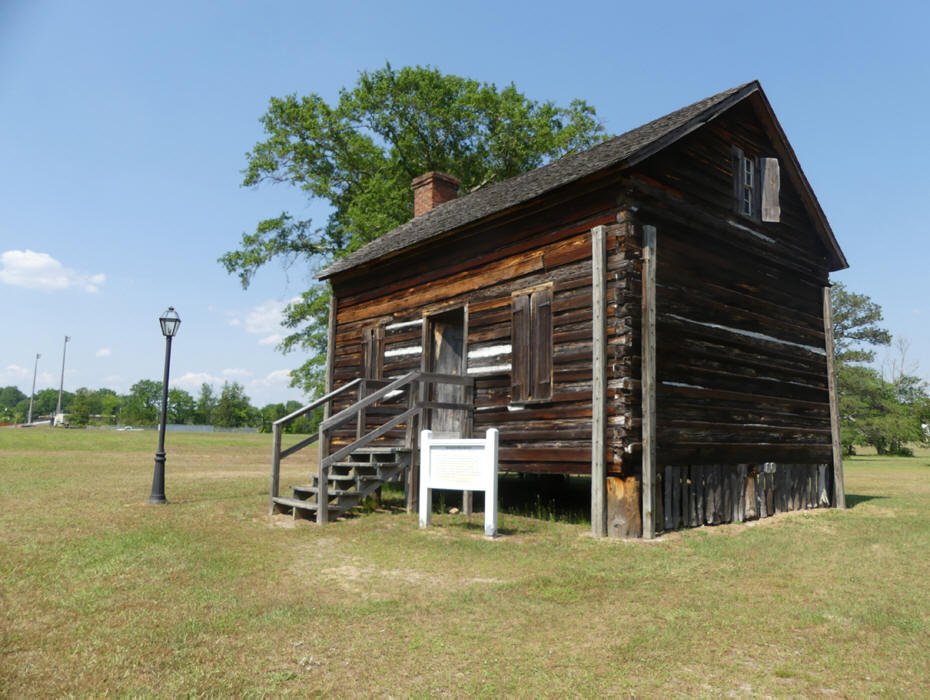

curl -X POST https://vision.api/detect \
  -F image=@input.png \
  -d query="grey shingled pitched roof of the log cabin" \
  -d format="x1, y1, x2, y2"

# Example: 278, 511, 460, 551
319, 81, 847, 280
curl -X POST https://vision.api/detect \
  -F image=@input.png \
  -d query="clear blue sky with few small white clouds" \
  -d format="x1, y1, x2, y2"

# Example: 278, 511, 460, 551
0, 0, 930, 405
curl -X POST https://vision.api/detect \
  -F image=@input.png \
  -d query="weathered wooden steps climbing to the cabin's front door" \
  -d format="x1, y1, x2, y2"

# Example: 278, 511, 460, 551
271, 447, 410, 521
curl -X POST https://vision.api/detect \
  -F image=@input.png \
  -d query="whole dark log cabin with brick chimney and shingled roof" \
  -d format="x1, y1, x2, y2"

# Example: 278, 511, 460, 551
273, 81, 847, 538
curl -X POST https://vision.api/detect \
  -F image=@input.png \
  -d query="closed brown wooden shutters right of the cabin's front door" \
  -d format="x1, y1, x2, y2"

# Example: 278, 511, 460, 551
510, 287, 552, 403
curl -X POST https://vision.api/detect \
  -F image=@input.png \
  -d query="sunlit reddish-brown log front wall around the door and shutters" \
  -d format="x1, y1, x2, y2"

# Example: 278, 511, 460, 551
334, 183, 634, 474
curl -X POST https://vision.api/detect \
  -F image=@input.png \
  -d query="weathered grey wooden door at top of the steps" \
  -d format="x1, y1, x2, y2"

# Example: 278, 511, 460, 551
426, 309, 465, 437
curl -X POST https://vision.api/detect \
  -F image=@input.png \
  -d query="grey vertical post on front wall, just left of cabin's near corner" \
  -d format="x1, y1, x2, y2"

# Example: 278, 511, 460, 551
591, 226, 607, 537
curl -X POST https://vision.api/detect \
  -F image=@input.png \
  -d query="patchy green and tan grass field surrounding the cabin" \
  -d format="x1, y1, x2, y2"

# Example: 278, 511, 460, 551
0, 429, 930, 697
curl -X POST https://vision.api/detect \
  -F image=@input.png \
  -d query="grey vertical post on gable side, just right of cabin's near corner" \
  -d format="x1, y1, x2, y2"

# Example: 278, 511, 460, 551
641, 226, 656, 540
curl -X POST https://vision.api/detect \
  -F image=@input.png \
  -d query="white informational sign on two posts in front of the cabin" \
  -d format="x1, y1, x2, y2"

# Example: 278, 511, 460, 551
420, 428, 497, 537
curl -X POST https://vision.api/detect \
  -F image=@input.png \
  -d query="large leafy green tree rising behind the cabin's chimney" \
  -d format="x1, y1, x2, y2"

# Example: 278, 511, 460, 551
220, 64, 606, 392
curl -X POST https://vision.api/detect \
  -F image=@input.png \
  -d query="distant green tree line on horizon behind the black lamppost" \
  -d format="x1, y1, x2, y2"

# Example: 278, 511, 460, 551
0, 379, 320, 433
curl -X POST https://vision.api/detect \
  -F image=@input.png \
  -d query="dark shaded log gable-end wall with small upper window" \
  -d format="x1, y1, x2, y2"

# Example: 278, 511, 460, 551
627, 97, 832, 465
